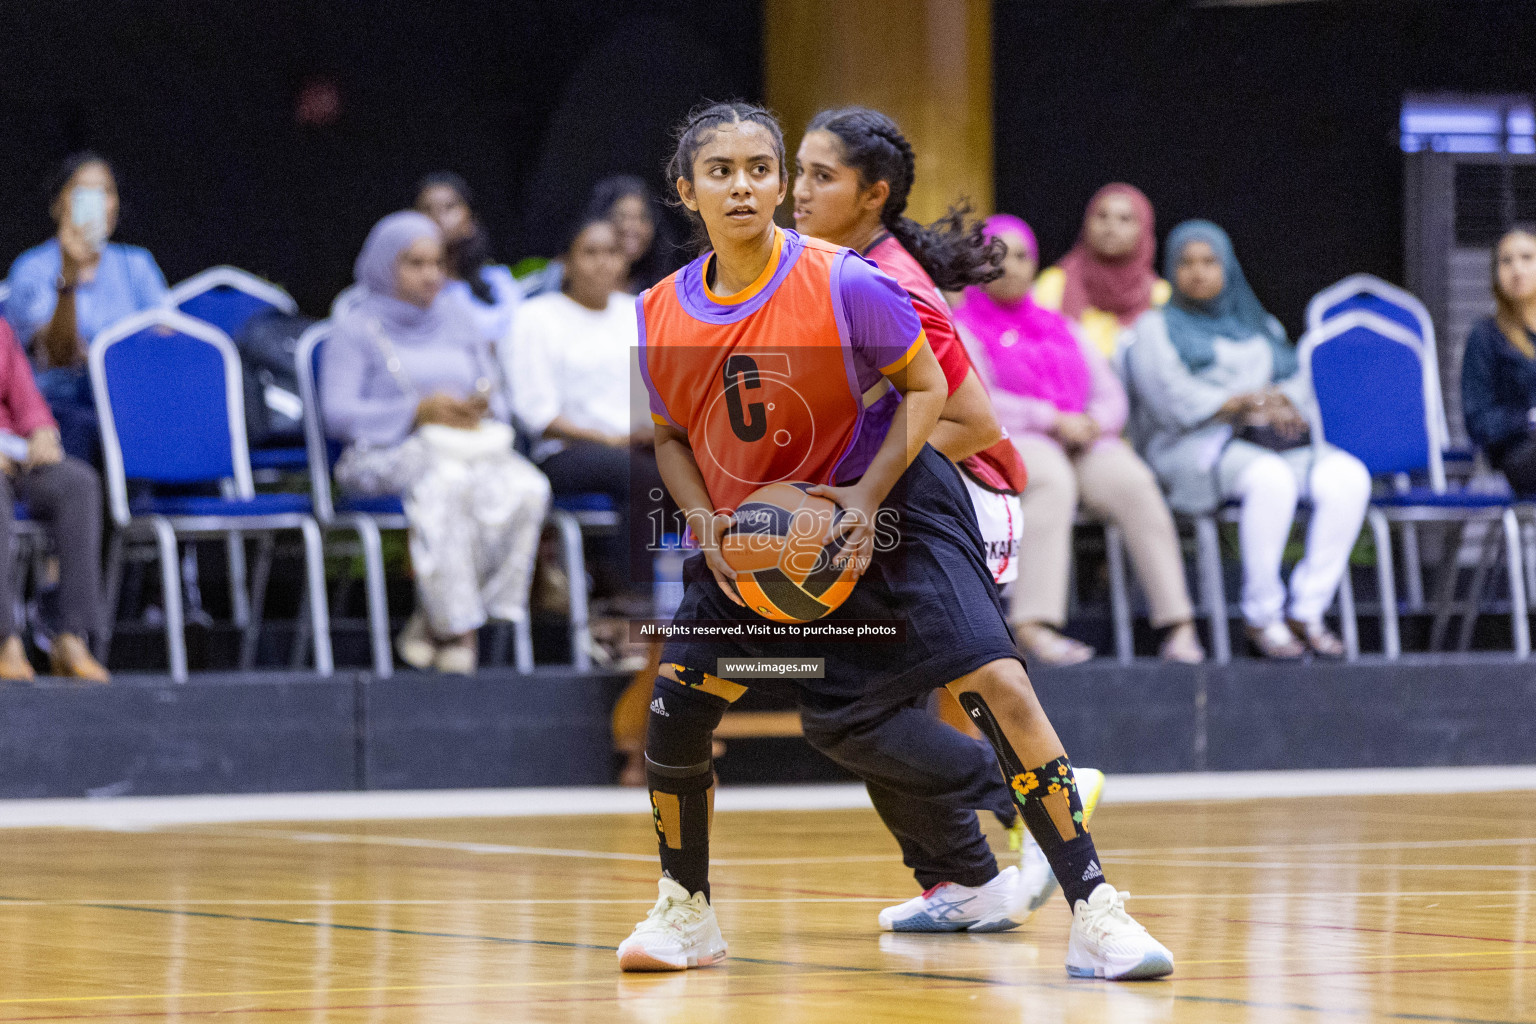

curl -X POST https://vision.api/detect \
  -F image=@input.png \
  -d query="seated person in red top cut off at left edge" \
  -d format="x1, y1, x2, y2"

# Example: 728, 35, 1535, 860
0, 313, 109, 683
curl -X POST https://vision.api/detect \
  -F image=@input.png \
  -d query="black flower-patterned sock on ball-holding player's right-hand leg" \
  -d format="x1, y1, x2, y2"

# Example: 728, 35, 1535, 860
960, 692, 1104, 907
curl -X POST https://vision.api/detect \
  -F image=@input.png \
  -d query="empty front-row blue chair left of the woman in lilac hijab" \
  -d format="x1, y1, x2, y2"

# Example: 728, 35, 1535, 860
89, 309, 332, 682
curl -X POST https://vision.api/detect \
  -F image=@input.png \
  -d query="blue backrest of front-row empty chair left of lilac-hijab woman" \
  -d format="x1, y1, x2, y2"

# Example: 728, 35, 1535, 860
89, 307, 255, 524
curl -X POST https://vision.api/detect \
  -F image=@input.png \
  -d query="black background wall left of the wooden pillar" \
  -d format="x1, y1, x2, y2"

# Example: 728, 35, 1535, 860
0, 0, 762, 313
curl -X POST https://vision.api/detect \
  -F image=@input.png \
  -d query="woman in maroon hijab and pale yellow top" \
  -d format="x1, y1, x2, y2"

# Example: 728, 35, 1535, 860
1034, 181, 1169, 359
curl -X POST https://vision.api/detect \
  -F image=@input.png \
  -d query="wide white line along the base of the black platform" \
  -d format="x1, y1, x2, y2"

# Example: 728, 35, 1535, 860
0, 765, 1536, 829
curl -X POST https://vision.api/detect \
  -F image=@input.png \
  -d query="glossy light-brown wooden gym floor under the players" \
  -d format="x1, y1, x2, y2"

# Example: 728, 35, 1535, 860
0, 792, 1536, 1024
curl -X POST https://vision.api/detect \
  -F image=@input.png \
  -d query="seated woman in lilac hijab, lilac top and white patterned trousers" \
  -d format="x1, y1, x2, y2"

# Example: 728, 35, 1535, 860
319, 210, 550, 674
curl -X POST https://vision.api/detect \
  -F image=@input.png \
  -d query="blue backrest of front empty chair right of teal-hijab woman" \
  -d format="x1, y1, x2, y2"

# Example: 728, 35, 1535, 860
1299, 310, 1445, 491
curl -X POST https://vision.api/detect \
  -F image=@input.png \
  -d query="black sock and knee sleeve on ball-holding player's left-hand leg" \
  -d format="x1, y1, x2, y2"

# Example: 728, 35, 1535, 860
645, 665, 746, 900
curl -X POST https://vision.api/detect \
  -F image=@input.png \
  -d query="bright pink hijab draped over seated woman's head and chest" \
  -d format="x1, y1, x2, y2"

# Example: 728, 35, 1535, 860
954, 213, 1094, 413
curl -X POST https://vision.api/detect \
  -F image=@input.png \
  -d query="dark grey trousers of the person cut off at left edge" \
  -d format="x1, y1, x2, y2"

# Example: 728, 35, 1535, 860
0, 456, 101, 637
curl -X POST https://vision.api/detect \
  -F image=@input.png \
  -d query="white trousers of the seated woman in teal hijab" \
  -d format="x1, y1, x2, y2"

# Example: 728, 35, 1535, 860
1227, 448, 1370, 626
